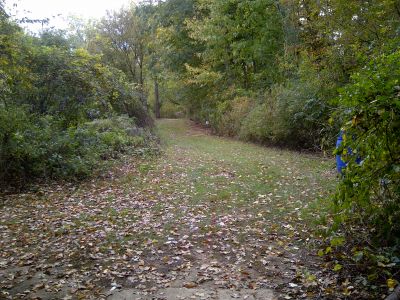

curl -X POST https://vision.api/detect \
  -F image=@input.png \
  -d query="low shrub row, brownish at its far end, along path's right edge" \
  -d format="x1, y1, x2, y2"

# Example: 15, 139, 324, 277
203, 80, 332, 150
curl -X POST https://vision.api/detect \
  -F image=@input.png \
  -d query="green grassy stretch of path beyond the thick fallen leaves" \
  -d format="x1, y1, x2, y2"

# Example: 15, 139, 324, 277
155, 120, 336, 234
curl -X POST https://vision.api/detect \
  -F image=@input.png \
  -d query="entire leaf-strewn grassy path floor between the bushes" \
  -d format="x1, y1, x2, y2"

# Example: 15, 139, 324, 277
0, 120, 340, 299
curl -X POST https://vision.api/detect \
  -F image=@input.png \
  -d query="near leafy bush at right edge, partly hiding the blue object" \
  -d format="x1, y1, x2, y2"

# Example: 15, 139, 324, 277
335, 48, 400, 246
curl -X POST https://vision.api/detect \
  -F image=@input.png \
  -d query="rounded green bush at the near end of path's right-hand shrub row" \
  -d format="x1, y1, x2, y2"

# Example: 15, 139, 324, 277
239, 80, 329, 150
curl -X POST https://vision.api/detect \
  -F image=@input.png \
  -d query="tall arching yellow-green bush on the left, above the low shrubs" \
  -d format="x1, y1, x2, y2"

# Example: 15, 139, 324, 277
0, 11, 152, 129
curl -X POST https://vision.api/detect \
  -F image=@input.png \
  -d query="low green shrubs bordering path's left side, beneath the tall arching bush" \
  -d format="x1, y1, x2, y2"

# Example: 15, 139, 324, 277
0, 108, 148, 183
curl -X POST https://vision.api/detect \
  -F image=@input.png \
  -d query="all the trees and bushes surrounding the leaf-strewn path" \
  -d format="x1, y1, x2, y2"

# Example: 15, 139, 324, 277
0, 0, 400, 298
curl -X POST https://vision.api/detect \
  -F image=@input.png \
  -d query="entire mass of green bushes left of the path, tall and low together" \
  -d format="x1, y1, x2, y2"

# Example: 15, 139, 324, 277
0, 16, 152, 185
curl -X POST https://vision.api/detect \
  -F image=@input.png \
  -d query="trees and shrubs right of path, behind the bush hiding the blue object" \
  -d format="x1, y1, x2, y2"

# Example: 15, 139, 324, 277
152, 0, 399, 151
